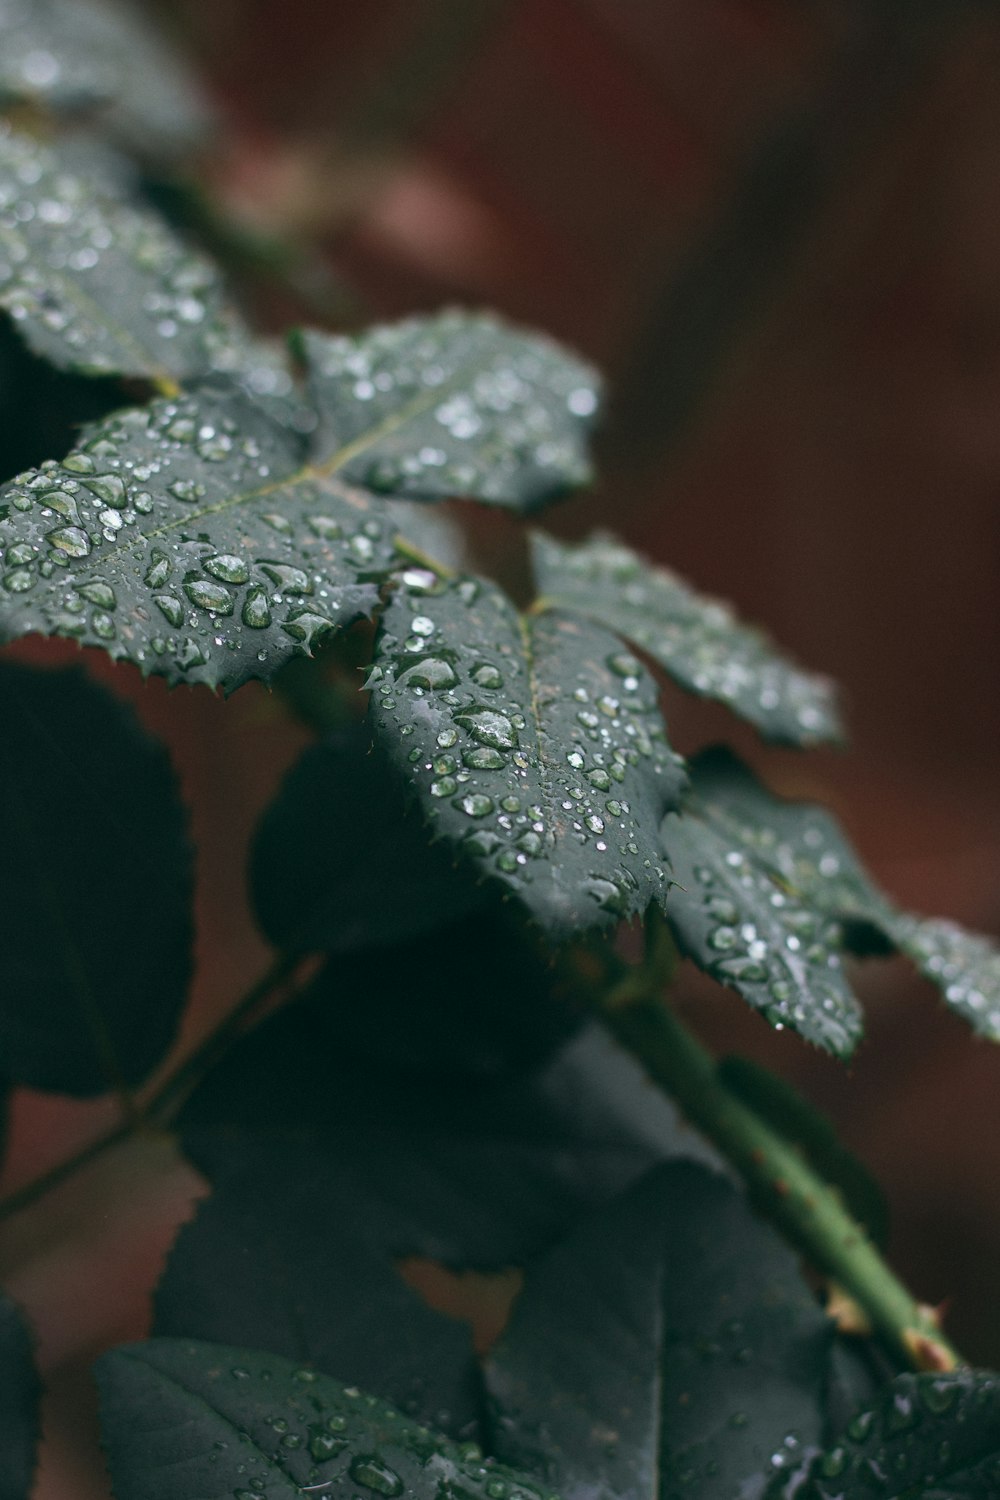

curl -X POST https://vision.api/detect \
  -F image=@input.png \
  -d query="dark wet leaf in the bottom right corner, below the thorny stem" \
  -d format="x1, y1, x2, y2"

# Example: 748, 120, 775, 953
766, 1370, 1000, 1500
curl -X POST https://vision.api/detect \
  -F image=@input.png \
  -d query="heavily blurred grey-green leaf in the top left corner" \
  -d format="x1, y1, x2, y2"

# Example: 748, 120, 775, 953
0, 0, 210, 158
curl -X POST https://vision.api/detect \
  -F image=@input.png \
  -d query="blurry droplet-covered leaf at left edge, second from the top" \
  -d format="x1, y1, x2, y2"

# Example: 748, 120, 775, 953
0, 126, 235, 381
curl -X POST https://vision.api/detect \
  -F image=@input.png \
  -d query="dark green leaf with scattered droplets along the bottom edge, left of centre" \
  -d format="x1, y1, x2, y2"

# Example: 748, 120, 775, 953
97, 1340, 560, 1500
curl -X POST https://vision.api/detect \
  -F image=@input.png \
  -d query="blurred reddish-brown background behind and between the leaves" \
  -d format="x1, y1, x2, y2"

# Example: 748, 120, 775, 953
1, 0, 1000, 1500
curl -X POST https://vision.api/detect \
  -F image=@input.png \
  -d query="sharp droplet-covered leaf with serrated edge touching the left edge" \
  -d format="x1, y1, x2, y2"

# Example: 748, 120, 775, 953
0, 393, 394, 686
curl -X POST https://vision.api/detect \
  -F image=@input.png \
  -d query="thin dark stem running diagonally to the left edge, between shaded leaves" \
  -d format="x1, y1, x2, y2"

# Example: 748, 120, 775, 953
0, 956, 300, 1223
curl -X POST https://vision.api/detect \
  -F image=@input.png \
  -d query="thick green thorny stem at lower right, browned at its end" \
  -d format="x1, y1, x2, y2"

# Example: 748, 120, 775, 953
603, 971, 963, 1371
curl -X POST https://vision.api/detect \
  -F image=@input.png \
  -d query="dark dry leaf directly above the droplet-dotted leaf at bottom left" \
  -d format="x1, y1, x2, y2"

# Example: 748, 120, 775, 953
153, 1133, 478, 1437
